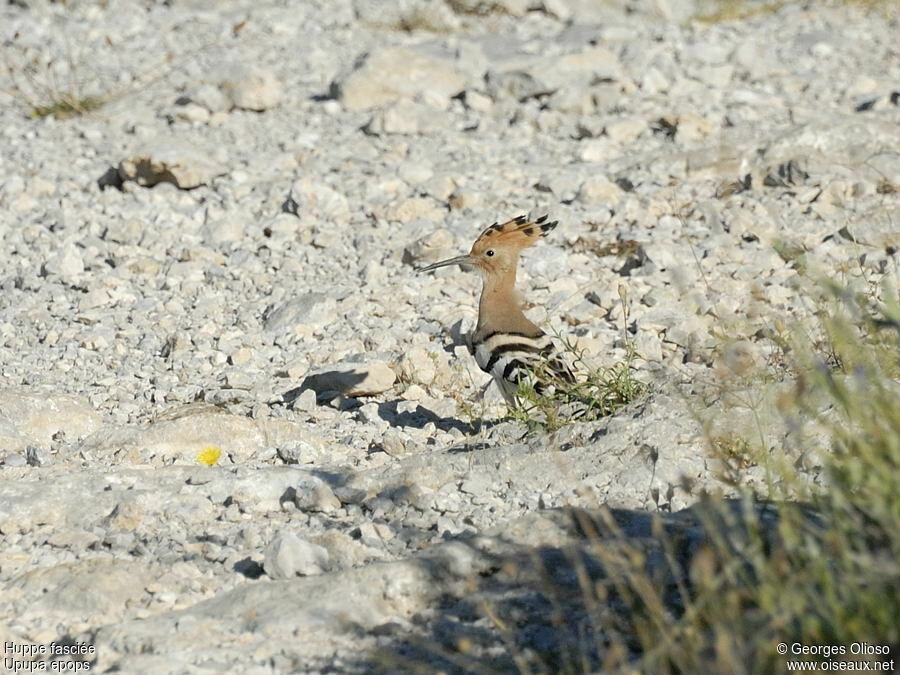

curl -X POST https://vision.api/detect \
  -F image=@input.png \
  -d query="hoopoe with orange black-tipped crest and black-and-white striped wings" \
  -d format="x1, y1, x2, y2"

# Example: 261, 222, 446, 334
419, 216, 575, 407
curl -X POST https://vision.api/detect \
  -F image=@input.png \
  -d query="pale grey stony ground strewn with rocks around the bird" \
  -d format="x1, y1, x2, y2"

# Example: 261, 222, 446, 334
0, 0, 900, 673
